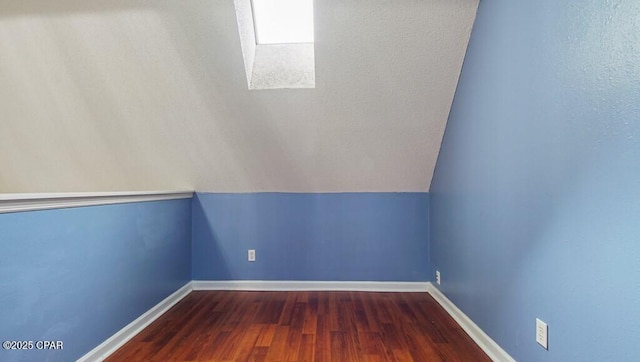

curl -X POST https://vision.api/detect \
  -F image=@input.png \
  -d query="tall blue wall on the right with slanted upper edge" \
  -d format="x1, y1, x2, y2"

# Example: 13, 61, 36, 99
430, 0, 640, 361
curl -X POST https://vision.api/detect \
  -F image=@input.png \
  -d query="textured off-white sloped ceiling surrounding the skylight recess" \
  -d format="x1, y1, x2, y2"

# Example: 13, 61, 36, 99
0, 0, 478, 192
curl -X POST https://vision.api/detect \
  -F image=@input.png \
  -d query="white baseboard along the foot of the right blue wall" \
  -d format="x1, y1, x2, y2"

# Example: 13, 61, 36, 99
427, 283, 515, 362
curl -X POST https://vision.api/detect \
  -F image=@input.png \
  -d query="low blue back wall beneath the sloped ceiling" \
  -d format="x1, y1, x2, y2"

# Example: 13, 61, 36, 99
192, 193, 430, 281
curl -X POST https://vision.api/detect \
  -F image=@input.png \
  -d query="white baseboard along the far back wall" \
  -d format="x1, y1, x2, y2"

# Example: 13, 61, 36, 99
191, 280, 429, 292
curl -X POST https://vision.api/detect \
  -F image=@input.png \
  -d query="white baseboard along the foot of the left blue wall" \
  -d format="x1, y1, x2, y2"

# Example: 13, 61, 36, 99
78, 282, 192, 362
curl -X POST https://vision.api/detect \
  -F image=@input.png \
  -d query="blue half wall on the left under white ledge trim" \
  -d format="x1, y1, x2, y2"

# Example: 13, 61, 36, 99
0, 199, 191, 361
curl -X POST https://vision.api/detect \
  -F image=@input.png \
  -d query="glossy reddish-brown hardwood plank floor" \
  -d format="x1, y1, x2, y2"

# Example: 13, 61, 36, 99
107, 291, 489, 361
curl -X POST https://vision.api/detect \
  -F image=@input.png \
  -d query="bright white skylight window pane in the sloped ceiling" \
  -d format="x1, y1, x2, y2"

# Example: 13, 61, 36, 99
252, 0, 313, 44
